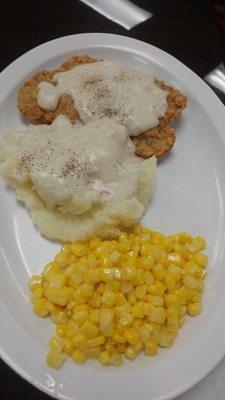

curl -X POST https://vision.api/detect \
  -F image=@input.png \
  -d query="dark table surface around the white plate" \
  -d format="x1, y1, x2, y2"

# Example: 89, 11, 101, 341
0, 0, 225, 400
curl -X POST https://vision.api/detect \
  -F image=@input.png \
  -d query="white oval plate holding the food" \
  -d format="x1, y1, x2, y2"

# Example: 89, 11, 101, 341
0, 33, 225, 400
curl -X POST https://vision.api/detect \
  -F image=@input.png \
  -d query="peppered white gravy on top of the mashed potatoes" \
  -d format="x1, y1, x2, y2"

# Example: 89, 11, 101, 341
4, 116, 146, 208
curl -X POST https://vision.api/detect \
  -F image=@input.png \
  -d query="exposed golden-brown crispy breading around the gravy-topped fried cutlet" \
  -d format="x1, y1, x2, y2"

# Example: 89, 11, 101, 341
17, 55, 187, 158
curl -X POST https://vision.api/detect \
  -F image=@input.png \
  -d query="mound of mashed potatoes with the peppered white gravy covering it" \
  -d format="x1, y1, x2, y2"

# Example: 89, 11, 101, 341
0, 117, 156, 241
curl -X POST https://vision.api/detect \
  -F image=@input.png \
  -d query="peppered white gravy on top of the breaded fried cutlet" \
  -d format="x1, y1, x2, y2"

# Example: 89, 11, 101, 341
37, 61, 168, 136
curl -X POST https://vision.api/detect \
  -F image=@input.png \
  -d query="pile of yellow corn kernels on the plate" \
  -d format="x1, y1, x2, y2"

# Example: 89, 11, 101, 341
29, 226, 207, 368
